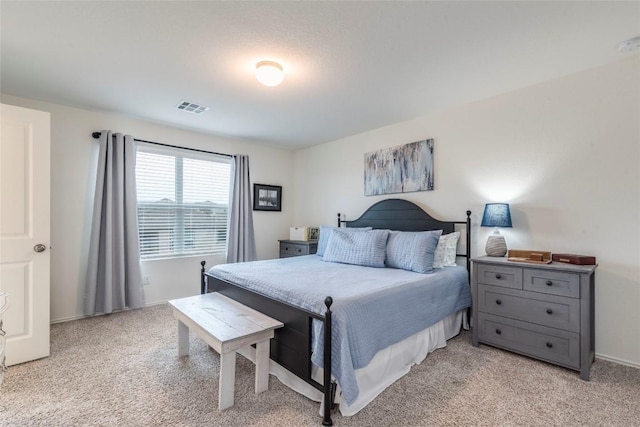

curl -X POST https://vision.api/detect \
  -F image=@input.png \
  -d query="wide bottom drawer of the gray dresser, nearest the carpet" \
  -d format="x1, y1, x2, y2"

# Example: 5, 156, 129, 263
478, 313, 580, 369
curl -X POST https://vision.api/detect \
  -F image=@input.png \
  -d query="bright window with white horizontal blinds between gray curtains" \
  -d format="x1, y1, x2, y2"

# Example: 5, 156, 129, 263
136, 143, 231, 259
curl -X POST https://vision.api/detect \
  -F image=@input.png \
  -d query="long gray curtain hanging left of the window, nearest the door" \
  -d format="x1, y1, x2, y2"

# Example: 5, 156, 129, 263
85, 131, 144, 315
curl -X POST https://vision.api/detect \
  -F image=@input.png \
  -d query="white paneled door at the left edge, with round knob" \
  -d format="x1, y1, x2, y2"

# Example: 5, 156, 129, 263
0, 104, 50, 365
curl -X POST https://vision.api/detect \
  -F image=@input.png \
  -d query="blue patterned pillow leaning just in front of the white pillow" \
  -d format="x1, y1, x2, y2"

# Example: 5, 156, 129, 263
385, 230, 442, 273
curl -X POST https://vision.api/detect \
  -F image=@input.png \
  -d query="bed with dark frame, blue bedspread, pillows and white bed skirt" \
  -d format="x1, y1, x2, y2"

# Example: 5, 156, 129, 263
201, 199, 471, 425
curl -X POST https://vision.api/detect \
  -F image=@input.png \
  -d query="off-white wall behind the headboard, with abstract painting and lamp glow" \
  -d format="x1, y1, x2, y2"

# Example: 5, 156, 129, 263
294, 56, 640, 366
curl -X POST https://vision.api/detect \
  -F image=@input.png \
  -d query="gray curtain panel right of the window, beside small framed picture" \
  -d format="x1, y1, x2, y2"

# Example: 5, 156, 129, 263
227, 155, 257, 263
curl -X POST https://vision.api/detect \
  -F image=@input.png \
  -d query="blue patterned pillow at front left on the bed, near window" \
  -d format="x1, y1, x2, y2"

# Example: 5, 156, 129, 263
322, 228, 389, 267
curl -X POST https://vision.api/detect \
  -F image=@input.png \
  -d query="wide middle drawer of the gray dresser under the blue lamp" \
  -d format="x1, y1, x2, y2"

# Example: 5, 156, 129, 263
478, 284, 580, 332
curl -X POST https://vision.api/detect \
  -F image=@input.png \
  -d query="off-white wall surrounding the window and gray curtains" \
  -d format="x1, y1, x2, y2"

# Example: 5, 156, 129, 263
1, 94, 293, 322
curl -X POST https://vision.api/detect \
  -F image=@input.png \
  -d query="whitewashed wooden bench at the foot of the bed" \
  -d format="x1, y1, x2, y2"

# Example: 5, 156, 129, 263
169, 292, 284, 410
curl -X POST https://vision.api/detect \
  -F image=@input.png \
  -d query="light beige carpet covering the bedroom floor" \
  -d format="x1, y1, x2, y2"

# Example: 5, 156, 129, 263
0, 305, 640, 426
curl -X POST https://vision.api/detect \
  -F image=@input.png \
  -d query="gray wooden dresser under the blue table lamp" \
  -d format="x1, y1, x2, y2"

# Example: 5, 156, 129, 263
471, 257, 597, 380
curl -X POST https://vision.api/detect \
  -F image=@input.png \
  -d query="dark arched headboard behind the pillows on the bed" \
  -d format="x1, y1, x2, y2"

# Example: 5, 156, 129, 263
338, 199, 471, 280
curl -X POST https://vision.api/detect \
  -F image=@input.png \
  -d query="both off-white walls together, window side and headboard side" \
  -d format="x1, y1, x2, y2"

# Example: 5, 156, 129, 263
1, 56, 640, 366
